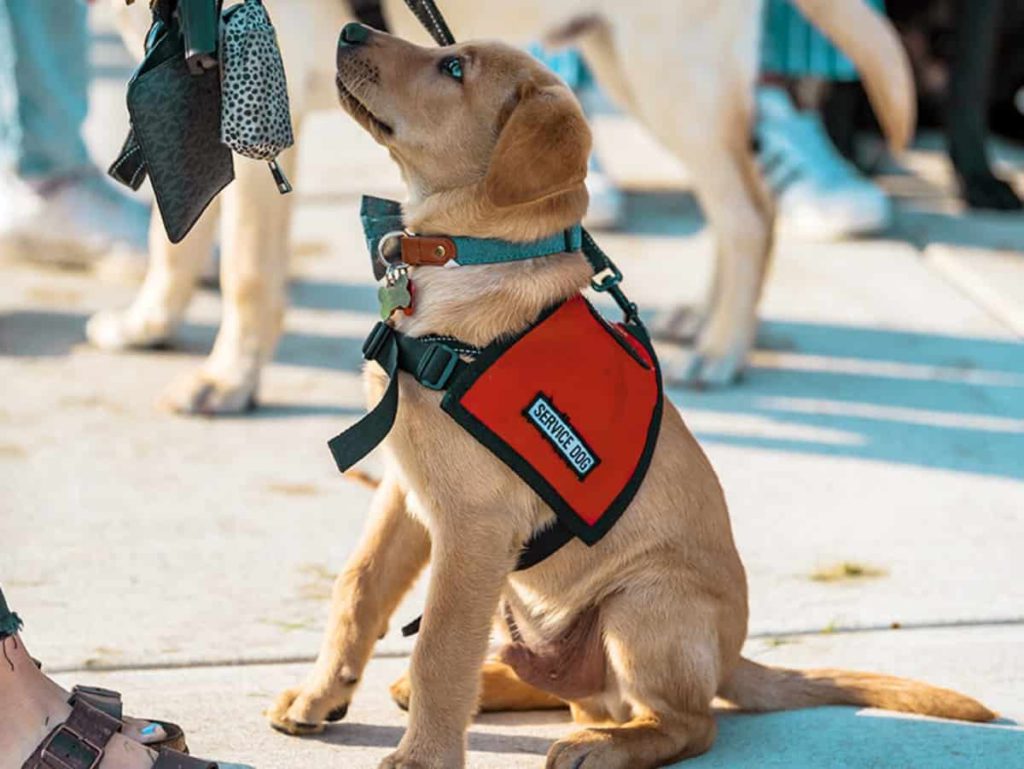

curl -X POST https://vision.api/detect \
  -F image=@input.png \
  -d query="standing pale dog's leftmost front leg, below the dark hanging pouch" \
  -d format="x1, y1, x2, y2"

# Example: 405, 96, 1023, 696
85, 201, 219, 351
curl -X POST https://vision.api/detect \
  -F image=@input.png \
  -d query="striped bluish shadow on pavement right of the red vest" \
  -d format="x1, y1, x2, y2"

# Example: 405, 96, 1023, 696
669, 323, 1024, 479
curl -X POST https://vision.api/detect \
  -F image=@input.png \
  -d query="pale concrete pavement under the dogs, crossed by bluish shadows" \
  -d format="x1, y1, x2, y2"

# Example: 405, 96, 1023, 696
0, 7, 1024, 769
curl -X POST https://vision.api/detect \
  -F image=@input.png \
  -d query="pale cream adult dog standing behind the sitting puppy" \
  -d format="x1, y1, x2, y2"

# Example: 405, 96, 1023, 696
94, 0, 914, 415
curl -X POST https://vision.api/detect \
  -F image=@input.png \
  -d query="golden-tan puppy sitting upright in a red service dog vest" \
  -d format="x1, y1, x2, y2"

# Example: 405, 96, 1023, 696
269, 28, 993, 769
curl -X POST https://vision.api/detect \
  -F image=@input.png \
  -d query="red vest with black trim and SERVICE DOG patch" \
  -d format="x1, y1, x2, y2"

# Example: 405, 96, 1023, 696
441, 296, 663, 545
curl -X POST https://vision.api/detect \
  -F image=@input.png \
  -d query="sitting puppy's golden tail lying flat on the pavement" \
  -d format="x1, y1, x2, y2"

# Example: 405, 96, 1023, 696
719, 658, 995, 721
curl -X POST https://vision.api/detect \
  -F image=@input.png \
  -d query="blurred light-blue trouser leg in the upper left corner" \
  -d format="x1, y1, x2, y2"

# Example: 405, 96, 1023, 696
0, 0, 89, 180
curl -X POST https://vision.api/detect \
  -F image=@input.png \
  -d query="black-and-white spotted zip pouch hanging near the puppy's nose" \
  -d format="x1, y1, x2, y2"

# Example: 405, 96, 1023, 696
220, 0, 295, 195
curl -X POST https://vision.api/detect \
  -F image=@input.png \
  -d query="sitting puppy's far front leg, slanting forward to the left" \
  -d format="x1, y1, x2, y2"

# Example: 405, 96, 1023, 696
267, 475, 430, 734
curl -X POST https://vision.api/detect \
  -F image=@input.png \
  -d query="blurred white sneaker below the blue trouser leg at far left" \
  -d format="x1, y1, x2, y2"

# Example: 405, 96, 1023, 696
0, 171, 150, 266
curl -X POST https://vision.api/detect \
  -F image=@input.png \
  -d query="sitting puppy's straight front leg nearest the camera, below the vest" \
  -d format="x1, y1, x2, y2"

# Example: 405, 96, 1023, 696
381, 515, 515, 769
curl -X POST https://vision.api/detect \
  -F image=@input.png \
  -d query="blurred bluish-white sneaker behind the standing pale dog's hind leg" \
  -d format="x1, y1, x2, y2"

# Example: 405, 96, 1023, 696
756, 86, 892, 241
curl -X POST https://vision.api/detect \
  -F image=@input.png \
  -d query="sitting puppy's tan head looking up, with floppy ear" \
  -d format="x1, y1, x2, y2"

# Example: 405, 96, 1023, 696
337, 24, 591, 215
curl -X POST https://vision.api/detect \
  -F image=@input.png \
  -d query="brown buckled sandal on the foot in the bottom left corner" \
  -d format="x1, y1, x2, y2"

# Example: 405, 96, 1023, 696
22, 693, 217, 769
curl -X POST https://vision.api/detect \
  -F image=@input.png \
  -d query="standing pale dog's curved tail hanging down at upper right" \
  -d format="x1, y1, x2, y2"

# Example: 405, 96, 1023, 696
796, 0, 918, 151
